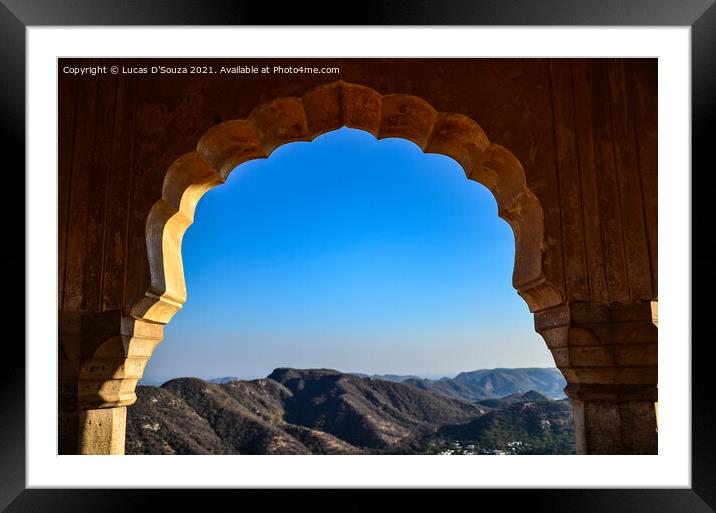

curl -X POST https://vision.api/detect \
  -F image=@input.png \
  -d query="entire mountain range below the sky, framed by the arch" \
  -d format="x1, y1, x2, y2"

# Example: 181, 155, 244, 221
125, 368, 573, 454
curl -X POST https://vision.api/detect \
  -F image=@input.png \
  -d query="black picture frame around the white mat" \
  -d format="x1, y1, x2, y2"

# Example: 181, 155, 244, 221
0, 0, 716, 513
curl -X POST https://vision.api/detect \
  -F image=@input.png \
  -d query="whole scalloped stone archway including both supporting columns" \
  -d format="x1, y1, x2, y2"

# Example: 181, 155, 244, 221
60, 81, 657, 454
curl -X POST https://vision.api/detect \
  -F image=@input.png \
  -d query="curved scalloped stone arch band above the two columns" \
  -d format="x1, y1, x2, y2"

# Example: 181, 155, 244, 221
130, 81, 563, 324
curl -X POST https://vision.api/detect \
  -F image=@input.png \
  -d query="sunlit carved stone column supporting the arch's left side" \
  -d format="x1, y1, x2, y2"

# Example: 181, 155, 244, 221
58, 311, 164, 454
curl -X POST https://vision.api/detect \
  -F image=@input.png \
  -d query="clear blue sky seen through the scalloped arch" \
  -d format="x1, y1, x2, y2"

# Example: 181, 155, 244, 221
144, 128, 554, 382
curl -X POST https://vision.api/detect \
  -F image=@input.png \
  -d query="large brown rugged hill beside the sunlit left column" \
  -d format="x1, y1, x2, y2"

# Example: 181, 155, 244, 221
125, 368, 488, 454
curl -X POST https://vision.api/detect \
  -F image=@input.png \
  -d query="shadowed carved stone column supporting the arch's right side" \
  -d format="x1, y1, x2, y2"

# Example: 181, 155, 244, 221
535, 302, 658, 454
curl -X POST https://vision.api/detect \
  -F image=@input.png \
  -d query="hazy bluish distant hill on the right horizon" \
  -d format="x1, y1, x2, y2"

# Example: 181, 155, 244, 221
402, 368, 567, 402
